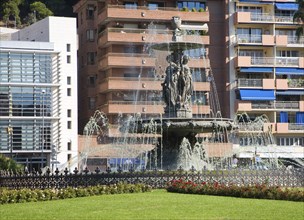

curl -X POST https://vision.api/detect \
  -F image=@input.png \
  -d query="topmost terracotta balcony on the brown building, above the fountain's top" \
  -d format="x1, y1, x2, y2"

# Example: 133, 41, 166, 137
97, 5, 209, 25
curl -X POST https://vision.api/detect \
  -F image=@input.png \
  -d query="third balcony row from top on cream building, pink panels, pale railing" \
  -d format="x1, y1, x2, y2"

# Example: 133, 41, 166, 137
235, 56, 304, 68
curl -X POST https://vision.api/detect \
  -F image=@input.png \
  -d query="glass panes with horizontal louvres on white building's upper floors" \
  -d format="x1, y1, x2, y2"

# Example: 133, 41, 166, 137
0, 51, 56, 153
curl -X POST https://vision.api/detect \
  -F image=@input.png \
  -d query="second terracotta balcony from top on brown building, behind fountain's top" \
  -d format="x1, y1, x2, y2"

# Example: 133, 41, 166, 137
98, 28, 209, 47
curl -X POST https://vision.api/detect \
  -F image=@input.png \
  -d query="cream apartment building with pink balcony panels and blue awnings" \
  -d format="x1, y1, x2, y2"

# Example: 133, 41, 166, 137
229, 0, 304, 158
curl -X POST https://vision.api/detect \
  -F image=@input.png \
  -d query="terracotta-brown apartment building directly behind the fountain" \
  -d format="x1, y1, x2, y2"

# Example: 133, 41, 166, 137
74, 0, 228, 128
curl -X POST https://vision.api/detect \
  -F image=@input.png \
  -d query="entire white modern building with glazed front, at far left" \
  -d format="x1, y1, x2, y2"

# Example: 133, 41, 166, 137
0, 17, 78, 170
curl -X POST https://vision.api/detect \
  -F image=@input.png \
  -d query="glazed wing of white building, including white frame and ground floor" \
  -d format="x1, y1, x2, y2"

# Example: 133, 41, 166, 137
0, 41, 59, 168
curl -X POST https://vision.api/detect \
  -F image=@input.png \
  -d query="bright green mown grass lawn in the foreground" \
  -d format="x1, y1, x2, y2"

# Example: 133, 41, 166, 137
0, 190, 304, 220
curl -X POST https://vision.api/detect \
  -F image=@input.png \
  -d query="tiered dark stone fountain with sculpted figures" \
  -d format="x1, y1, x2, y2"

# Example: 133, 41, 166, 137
121, 17, 235, 170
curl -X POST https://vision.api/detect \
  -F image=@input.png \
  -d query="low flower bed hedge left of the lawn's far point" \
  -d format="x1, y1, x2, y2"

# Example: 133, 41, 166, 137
0, 183, 151, 204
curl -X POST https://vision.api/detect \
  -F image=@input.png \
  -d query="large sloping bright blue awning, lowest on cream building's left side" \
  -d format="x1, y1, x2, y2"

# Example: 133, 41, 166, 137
240, 89, 275, 101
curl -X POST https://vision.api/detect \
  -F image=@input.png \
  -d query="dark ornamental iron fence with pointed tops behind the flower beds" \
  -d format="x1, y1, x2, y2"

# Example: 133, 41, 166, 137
0, 168, 304, 189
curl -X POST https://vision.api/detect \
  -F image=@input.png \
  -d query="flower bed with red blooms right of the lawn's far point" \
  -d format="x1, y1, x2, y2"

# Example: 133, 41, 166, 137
167, 179, 304, 202
